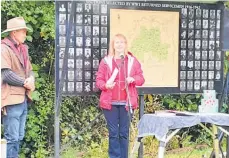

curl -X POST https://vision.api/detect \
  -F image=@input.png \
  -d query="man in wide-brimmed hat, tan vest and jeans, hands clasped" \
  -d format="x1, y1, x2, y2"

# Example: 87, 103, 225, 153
1, 17, 35, 158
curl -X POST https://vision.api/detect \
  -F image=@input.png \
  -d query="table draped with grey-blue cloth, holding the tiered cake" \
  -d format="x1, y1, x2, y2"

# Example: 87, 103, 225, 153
130, 112, 229, 158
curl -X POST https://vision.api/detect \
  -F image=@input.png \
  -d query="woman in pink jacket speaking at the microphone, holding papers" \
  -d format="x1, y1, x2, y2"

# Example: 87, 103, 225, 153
96, 34, 145, 158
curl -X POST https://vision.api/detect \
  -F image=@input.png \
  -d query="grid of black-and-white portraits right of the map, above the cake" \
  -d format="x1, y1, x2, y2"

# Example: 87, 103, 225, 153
179, 8, 222, 92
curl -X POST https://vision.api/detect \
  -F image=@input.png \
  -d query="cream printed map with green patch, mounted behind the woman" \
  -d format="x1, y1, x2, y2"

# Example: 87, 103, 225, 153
110, 9, 179, 87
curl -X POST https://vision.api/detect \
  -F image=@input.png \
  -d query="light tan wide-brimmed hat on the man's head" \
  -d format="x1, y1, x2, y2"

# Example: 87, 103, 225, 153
2, 17, 31, 33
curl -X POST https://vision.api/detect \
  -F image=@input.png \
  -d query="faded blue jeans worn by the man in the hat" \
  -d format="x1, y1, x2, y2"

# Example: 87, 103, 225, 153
2, 101, 28, 158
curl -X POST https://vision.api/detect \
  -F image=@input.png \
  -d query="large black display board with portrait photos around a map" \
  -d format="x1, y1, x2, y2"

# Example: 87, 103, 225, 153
56, 1, 224, 95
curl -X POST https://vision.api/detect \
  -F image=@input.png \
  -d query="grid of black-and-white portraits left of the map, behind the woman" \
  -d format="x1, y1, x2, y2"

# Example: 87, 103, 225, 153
58, 1, 108, 94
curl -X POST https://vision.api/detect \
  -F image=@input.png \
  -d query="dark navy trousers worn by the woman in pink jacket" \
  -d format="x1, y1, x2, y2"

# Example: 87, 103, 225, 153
103, 105, 129, 158
